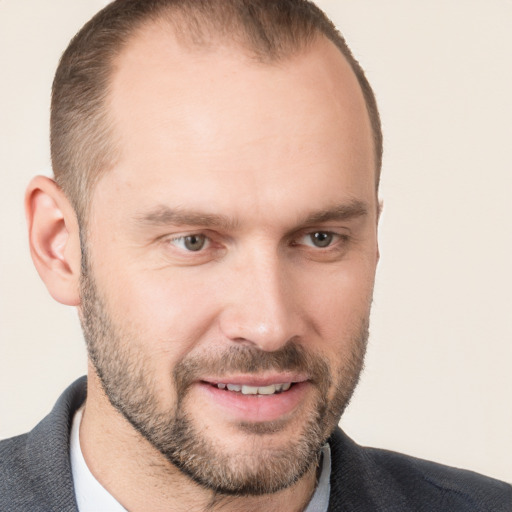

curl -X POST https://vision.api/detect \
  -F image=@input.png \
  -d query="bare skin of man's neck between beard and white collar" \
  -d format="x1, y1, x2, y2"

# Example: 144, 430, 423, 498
80, 368, 317, 512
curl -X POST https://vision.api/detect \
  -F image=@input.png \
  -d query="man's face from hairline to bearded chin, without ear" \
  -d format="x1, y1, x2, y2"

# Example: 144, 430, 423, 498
81, 29, 378, 494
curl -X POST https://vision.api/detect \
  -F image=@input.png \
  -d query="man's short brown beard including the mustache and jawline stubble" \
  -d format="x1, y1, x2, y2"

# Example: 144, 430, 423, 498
80, 258, 369, 496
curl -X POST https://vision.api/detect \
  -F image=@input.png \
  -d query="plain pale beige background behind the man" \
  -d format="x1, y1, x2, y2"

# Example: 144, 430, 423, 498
0, 0, 512, 481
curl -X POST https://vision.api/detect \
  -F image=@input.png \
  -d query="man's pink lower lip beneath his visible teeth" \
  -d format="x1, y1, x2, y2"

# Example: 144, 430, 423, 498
198, 382, 310, 423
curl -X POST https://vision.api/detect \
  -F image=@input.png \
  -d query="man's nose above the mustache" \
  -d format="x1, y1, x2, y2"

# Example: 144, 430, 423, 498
220, 247, 304, 352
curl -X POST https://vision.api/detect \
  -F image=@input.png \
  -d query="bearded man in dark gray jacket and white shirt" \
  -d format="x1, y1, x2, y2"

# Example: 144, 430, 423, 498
0, 0, 512, 512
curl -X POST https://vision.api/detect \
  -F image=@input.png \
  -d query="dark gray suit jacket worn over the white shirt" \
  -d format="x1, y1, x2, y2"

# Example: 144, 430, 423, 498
0, 378, 512, 512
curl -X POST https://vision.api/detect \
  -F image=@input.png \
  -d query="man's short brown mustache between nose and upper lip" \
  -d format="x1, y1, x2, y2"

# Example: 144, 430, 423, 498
174, 342, 331, 397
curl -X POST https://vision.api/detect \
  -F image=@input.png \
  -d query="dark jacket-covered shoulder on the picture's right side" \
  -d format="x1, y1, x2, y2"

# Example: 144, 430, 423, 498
330, 431, 512, 512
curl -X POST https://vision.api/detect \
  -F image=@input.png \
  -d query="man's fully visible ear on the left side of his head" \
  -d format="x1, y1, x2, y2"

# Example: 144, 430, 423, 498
25, 176, 81, 306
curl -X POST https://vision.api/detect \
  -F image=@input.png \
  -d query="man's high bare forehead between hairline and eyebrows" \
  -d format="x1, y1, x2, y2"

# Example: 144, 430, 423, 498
96, 25, 375, 222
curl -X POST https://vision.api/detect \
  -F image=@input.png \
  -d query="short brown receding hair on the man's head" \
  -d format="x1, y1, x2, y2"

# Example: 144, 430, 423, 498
50, 0, 382, 222
